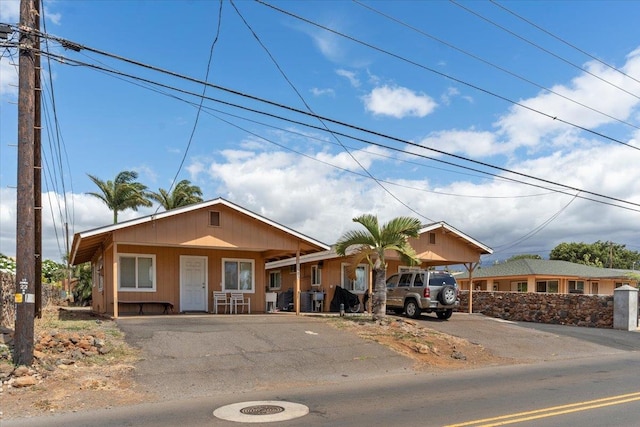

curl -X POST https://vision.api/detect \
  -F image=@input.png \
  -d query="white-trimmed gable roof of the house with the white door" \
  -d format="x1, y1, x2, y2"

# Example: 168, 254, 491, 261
69, 198, 329, 265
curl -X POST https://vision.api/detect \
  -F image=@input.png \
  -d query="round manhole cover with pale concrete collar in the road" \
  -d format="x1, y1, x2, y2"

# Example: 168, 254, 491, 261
213, 400, 309, 423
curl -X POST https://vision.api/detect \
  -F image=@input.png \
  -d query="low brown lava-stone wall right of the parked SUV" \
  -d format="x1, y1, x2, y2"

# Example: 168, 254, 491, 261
458, 291, 613, 328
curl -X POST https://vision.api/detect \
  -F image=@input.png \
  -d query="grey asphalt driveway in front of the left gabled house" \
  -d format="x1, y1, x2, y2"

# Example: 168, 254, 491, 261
118, 314, 412, 399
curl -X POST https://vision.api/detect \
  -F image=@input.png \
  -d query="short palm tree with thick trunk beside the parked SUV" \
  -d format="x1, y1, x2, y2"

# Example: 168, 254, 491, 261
336, 214, 421, 320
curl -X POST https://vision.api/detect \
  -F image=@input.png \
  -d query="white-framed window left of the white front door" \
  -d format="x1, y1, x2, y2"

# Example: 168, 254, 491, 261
118, 254, 156, 292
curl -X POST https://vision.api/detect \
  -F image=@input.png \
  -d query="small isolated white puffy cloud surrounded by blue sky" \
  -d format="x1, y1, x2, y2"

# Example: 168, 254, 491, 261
363, 86, 438, 119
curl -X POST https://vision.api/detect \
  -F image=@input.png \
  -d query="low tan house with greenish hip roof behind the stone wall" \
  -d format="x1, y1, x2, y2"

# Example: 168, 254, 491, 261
456, 259, 638, 295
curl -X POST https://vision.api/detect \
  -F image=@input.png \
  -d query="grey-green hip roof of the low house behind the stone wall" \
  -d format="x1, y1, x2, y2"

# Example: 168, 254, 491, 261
473, 258, 630, 279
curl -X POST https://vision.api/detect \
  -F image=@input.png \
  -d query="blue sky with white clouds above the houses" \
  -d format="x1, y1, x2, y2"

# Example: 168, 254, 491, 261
0, 0, 640, 263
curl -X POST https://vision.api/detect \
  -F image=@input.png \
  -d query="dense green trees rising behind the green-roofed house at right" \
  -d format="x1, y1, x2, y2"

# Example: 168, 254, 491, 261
549, 240, 640, 270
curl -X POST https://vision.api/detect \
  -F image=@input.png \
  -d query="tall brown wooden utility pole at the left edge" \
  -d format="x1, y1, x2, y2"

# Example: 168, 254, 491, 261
13, 0, 40, 366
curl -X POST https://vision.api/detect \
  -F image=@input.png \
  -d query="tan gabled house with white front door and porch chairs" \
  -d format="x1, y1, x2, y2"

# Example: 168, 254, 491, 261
70, 198, 329, 317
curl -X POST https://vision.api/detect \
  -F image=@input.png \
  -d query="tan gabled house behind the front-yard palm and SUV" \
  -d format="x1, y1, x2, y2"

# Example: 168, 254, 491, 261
266, 222, 493, 311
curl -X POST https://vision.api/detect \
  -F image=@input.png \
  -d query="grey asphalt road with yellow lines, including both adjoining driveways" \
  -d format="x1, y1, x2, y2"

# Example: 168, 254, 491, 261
2, 313, 640, 427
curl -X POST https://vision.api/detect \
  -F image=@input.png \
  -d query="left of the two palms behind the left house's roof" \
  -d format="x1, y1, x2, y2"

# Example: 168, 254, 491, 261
87, 171, 152, 224
